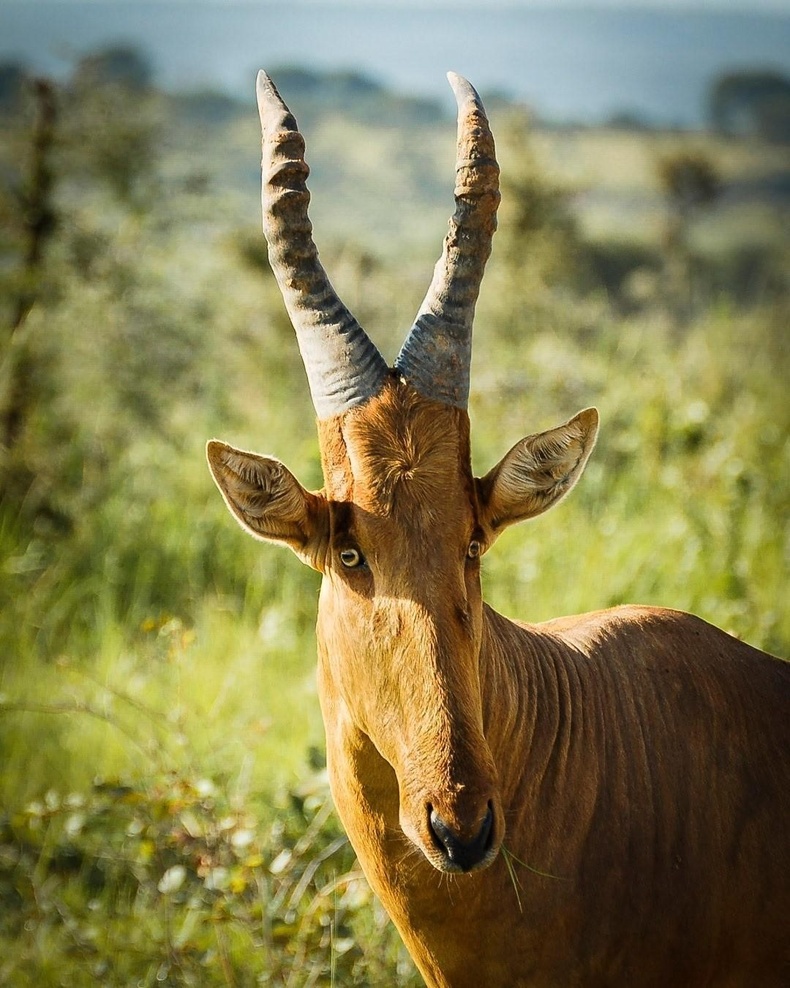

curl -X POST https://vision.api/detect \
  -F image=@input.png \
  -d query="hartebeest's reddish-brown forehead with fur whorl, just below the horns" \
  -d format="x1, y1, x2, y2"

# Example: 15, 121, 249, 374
321, 380, 472, 521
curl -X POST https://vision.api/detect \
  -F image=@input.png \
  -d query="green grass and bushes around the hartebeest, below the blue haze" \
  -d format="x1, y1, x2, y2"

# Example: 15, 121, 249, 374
0, 50, 790, 986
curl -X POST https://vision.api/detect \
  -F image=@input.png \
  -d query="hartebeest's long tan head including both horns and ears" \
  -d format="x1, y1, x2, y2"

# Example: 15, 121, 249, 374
208, 73, 598, 872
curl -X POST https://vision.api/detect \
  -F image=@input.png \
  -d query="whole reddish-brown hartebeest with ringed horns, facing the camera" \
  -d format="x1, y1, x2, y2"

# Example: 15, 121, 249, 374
208, 73, 790, 988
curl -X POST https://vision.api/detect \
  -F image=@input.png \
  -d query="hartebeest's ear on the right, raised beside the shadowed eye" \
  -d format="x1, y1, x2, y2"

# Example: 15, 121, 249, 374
477, 408, 598, 536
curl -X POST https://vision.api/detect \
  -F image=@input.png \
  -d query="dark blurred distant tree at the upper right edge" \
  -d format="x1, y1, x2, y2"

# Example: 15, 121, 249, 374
708, 70, 790, 142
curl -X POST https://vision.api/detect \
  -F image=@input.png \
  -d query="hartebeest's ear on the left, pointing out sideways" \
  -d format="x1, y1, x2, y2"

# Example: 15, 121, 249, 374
206, 439, 329, 569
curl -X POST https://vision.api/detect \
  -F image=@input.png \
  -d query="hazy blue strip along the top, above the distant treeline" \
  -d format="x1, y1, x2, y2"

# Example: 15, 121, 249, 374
6, 0, 790, 127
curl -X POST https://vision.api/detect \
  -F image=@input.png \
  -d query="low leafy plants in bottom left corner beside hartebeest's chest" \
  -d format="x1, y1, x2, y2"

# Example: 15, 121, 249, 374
0, 764, 415, 988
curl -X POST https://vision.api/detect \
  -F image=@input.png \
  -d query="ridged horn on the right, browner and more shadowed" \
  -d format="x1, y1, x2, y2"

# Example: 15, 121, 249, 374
395, 72, 499, 408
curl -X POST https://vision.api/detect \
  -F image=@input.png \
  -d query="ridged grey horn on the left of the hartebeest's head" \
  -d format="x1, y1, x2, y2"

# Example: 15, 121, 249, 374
256, 72, 388, 419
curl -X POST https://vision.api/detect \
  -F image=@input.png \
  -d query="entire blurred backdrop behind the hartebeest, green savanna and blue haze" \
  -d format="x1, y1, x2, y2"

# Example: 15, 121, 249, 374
0, 0, 790, 988
